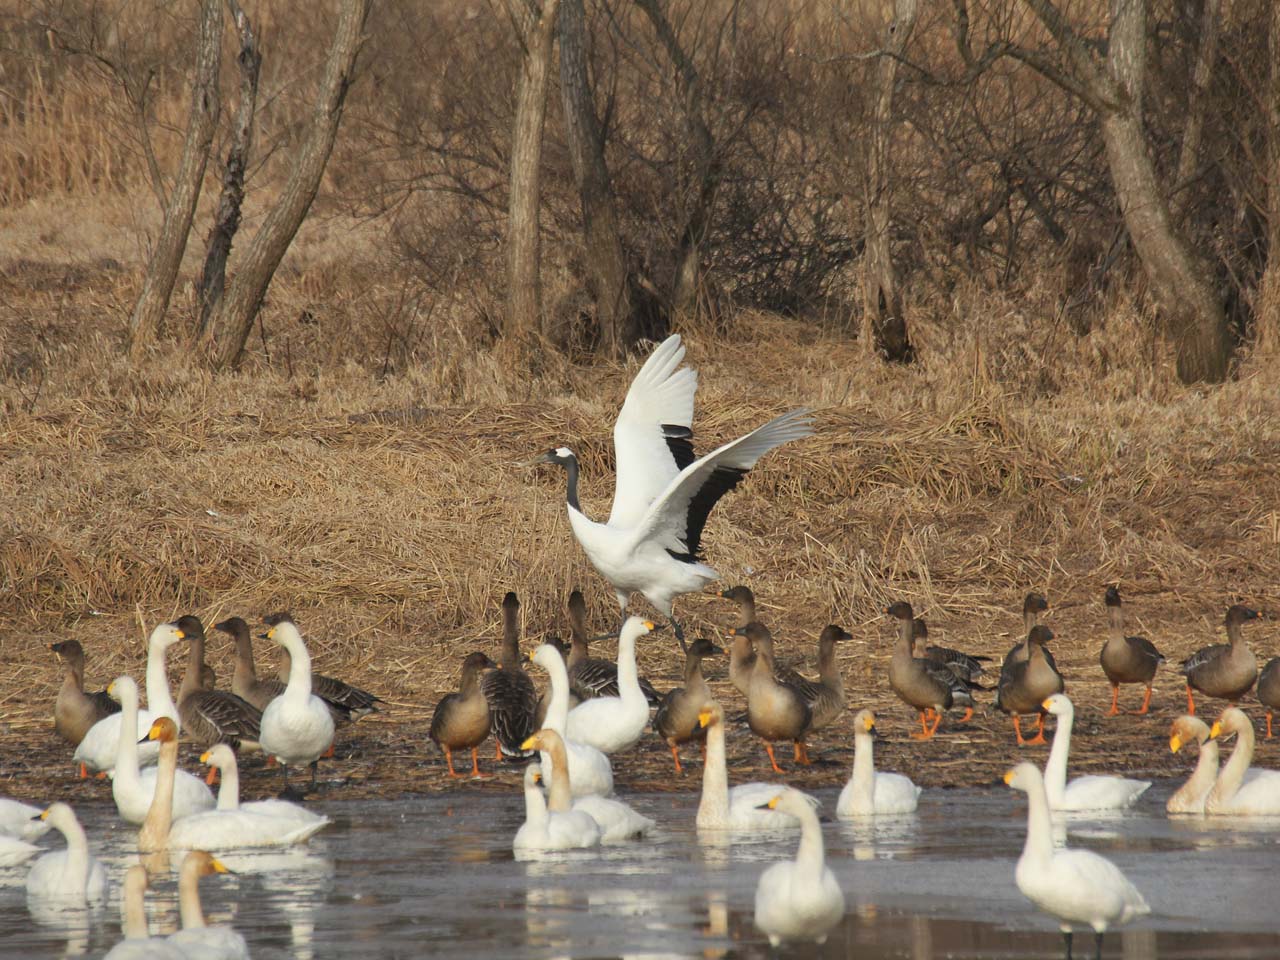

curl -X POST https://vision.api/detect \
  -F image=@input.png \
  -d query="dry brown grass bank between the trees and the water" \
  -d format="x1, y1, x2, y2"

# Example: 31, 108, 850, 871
0, 193, 1280, 794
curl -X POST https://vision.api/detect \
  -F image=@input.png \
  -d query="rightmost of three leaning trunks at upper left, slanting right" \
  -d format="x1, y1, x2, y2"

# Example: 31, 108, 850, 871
204, 0, 371, 369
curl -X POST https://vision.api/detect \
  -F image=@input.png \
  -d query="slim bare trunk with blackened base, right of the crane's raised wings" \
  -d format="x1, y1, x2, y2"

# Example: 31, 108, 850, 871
861, 0, 916, 364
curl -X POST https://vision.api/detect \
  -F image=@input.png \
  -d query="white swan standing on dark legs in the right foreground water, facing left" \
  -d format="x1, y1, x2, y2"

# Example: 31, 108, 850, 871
1005, 762, 1151, 956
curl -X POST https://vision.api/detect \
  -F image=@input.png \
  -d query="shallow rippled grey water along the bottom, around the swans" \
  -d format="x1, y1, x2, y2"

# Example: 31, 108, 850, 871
0, 783, 1280, 960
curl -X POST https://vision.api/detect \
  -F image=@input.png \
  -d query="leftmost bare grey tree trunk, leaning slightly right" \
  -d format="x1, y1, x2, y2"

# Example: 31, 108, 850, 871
129, 0, 223, 360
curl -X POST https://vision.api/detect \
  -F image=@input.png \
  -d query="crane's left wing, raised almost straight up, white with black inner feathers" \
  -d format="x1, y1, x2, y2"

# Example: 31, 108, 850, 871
609, 334, 698, 527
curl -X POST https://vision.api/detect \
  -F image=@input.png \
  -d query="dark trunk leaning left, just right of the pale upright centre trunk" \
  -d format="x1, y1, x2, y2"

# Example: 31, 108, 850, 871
559, 0, 639, 357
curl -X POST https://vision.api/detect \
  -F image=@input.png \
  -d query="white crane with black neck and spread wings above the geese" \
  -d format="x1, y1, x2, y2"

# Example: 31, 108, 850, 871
535, 334, 813, 648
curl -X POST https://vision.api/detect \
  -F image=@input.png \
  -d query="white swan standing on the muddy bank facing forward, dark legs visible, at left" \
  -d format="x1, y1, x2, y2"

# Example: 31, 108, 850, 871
259, 613, 333, 787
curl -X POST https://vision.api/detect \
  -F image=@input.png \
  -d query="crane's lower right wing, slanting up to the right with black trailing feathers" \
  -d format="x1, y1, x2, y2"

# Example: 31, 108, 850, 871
636, 410, 813, 563
